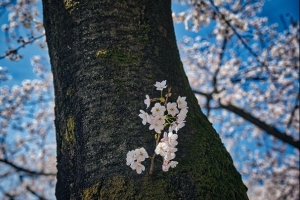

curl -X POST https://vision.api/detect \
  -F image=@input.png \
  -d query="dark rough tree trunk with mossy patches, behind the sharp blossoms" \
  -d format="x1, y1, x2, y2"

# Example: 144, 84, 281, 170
43, 0, 248, 200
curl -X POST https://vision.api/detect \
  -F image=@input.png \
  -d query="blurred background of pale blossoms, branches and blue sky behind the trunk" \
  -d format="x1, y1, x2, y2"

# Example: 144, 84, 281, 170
0, 0, 300, 200
